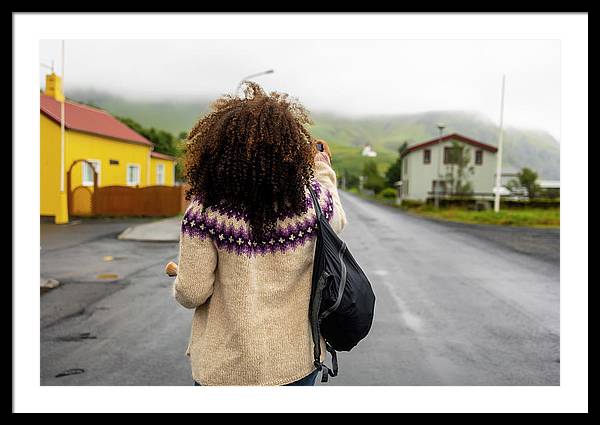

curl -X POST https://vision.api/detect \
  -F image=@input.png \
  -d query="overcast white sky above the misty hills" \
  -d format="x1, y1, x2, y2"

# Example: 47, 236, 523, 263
40, 40, 560, 140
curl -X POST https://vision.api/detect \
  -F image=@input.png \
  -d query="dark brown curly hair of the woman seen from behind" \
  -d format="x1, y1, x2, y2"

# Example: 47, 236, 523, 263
185, 81, 316, 241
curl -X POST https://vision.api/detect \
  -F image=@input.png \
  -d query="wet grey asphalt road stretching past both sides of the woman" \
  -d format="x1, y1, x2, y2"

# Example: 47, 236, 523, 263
41, 193, 560, 385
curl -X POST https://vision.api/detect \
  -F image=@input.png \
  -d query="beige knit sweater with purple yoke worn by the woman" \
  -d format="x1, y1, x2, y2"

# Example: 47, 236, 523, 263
173, 154, 346, 385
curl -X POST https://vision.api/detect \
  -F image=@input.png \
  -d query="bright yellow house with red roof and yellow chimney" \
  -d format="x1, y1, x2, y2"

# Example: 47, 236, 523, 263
40, 73, 176, 223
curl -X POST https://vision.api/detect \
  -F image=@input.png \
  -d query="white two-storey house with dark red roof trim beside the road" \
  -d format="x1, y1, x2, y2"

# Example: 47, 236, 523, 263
400, 133, 498, 201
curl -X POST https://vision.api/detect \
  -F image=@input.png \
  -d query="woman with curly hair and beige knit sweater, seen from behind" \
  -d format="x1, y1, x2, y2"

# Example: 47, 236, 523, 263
173, 82, 346, 385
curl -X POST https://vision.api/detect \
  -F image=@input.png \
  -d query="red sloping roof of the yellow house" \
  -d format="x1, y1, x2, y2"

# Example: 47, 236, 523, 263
40, 93, 154, 147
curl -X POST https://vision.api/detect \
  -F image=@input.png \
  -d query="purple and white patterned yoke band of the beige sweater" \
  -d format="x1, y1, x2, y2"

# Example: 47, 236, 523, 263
181, 181, 333, 256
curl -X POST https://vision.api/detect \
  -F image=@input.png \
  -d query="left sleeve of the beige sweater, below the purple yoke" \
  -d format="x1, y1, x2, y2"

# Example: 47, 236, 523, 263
173, 210, 217, 308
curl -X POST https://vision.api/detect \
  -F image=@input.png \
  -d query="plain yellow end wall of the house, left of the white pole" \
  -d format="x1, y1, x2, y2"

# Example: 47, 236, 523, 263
40, 114, 66, 216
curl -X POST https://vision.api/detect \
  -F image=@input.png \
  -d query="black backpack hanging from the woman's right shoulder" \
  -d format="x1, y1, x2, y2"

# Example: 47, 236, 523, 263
308, 185, 375, 382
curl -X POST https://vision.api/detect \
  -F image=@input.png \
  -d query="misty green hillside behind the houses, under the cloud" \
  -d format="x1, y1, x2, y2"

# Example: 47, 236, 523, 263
68, 91, 560, 180
